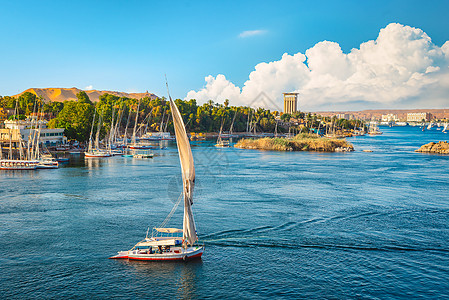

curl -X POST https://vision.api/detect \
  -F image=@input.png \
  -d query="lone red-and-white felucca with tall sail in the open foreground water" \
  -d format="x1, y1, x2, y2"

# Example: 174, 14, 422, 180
110, 97, 204, 261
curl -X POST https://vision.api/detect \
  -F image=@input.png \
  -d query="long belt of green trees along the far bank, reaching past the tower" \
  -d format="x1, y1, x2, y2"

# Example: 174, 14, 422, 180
0, 91, 364, 142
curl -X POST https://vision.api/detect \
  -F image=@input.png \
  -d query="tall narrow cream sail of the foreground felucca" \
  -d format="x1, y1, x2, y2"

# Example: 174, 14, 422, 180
170, 97, 198, 245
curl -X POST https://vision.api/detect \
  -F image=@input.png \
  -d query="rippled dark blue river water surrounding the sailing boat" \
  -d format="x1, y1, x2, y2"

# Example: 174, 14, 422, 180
0, 127, 449, 299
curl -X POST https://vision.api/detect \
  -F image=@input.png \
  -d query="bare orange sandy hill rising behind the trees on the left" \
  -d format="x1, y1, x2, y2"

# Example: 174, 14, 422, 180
13, 88, 157, 102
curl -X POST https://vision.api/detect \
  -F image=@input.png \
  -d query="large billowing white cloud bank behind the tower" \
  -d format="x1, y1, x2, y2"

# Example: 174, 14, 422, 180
186, 23, 449, 110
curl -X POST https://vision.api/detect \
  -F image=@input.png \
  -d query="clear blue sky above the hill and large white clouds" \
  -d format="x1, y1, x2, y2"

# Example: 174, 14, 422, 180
0, 0, 449, 108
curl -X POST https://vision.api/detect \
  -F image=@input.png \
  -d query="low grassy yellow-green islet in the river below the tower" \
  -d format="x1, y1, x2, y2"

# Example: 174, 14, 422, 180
234, 134, 354, 152
